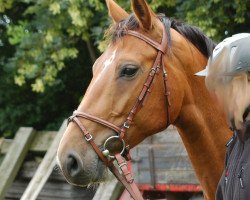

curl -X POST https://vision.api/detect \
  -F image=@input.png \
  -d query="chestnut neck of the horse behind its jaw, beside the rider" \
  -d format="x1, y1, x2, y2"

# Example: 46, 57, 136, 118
167, 38, 231, 199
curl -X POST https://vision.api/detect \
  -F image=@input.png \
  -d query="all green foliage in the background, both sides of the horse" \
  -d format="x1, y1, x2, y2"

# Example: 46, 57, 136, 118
0, 0, 250, 136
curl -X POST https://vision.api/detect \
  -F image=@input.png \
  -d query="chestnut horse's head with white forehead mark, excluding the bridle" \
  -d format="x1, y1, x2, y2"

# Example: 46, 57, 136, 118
58, 1, 174, 185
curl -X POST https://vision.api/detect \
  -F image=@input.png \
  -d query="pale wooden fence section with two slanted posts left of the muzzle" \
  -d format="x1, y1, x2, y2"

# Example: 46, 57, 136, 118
0, 121, 66, 200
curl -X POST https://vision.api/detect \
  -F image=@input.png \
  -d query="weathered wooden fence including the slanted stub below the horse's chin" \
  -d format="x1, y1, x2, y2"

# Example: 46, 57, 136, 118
0, 120, 118, 200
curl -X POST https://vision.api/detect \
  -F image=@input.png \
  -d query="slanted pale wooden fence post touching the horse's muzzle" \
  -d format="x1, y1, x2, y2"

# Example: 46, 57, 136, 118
21, 120, 67, 200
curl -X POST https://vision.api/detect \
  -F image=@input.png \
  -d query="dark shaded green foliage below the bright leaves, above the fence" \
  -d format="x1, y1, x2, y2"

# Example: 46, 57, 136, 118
0, 40, 91, 137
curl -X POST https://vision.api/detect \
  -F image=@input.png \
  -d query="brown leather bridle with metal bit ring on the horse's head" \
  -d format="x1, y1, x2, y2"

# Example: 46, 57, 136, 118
68, 18, 171, 200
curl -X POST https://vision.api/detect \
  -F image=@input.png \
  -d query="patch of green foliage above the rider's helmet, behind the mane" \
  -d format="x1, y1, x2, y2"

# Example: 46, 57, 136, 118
174, 0, 250, 41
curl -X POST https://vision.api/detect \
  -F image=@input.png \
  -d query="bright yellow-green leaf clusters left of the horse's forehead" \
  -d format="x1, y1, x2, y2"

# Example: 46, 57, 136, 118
4, 0, 104, 93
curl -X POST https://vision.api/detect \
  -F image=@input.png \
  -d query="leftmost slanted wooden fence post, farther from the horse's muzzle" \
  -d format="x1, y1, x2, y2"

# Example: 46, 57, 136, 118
0, 127, 35, 200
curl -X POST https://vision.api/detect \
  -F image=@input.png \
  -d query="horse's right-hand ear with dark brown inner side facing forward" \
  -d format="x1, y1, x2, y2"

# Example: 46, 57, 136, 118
131, 0, 155, 30
